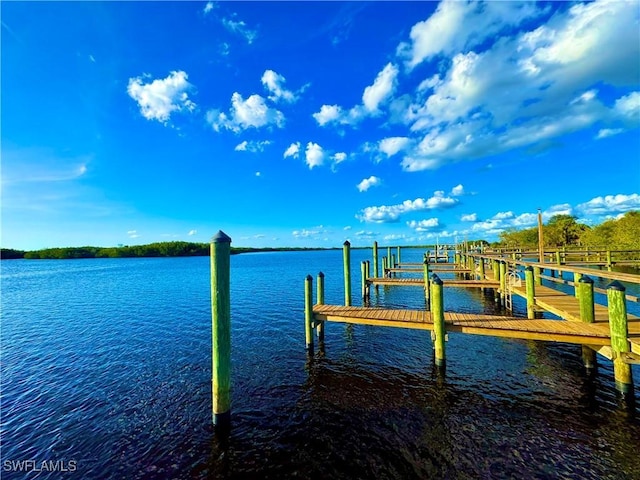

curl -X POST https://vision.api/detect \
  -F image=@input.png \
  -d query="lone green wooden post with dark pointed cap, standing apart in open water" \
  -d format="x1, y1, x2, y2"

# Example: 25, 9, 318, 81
211, 230, 231, 428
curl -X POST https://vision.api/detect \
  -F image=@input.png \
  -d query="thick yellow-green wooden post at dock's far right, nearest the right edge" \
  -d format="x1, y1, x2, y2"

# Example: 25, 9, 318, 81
607, 280, 633, 395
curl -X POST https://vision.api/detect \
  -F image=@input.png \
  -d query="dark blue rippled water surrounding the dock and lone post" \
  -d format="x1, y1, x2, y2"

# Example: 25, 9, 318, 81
0, 250, 640, 479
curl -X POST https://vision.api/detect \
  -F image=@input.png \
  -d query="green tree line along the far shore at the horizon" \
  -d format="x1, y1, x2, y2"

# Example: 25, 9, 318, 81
0, 211, 640, 260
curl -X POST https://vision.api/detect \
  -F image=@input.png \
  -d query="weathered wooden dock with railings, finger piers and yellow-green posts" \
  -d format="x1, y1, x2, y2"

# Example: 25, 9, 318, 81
305, 242, 640, 395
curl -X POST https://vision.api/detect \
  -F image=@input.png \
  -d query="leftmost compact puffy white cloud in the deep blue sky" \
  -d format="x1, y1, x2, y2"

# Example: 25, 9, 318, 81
127, 70, 196, 124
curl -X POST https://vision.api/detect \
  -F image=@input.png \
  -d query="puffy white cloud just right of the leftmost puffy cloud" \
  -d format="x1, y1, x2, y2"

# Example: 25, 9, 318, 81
206, 92, 285, 133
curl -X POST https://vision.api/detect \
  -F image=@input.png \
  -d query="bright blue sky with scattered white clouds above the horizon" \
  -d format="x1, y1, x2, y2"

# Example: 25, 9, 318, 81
1, 1, 640, 249
